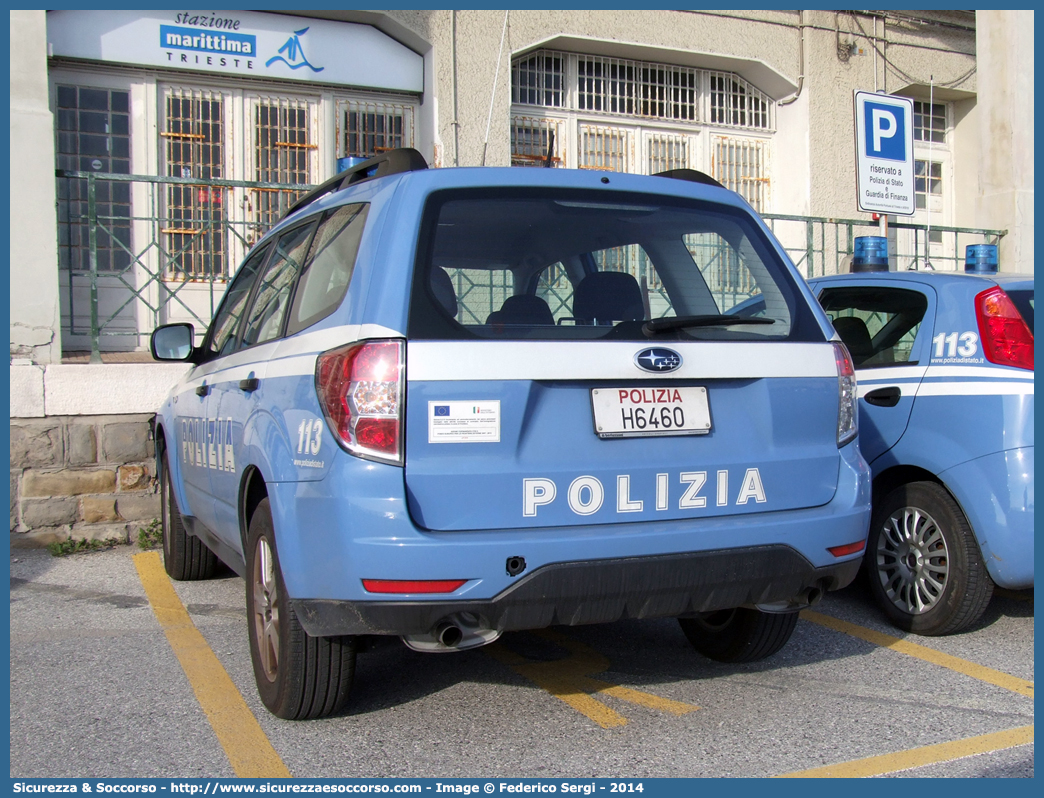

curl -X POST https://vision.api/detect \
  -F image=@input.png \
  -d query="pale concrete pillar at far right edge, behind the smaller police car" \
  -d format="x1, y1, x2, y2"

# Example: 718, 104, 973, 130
975, 10, 1036, 274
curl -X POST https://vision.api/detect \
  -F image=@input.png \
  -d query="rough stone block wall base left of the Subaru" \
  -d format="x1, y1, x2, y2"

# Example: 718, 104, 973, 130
10, 414, 160, 547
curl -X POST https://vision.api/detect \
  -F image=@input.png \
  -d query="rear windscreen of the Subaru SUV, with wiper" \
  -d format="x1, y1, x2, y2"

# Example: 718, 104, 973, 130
408, 189, 822, 341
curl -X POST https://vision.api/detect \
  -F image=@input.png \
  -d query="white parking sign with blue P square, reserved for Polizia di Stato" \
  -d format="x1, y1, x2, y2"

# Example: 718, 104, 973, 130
855, 91, 915, 218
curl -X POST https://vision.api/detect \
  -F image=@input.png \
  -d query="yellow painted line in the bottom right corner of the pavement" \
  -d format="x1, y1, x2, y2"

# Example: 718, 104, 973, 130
777, 726, 1034, 778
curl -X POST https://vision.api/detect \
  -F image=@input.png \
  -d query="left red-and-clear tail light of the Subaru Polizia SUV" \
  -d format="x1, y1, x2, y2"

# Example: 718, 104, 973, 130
315, 341, 405, 466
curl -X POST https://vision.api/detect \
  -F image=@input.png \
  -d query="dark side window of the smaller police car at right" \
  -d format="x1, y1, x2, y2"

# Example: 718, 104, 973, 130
820, 286, 928, 369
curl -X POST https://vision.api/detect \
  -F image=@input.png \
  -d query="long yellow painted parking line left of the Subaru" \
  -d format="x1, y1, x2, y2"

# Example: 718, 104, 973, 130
134, 551, 290, 778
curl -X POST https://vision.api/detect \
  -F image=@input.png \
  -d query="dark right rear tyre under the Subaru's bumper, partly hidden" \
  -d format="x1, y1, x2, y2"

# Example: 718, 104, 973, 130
678, 607, 798, 662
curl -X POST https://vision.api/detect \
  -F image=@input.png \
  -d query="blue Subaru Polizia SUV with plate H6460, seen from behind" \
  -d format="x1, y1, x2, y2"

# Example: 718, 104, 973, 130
151, 150, 871, 719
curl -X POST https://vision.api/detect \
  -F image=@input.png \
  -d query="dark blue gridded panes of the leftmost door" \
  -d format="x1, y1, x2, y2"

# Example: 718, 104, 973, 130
54, 86, 132, 272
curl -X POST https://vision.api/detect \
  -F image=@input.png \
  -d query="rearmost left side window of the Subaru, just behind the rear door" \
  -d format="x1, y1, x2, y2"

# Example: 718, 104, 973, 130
286, 205, 370, 335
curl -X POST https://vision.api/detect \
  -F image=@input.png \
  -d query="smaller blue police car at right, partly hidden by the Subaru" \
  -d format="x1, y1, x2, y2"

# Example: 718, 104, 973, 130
809, 252, 1034, 635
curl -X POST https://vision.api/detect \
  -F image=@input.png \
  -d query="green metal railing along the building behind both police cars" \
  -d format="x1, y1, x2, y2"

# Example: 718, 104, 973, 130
55, 169, 1006, 362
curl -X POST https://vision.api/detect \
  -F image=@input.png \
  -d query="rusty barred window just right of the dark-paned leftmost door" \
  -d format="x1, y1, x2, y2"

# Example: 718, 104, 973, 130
160, 87, 229, 280
